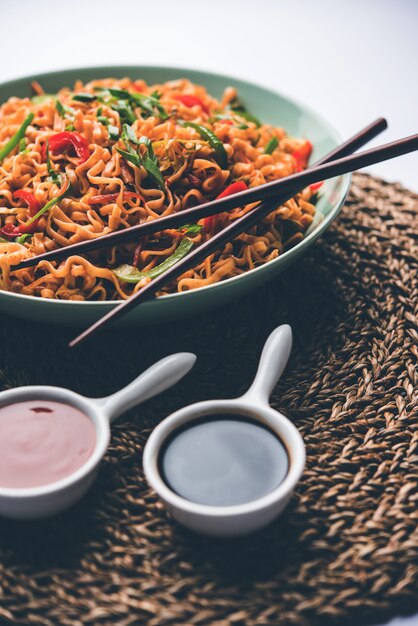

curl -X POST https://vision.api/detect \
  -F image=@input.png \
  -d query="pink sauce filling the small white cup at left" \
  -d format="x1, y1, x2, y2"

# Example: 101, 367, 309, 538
0, 400, 96, 487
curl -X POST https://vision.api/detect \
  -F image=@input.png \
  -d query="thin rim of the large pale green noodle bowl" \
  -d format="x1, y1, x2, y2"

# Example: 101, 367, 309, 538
0, 64, 352, 309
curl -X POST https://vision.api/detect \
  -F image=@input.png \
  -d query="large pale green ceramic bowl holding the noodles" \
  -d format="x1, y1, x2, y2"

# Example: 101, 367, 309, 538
0, 66, 350, 325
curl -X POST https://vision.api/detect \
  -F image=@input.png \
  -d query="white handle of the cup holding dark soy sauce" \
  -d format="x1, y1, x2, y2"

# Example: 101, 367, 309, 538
242, 324, 292, 404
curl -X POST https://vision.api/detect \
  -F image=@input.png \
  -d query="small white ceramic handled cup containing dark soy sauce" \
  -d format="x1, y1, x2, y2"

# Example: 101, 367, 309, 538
143, 325, 305, 537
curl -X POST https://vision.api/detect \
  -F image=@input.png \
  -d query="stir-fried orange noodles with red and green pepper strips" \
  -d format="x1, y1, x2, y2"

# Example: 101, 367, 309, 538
0, 78, 319, 300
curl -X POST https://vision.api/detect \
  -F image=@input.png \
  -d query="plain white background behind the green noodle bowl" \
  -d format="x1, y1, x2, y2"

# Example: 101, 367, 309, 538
0, 0, 418, 626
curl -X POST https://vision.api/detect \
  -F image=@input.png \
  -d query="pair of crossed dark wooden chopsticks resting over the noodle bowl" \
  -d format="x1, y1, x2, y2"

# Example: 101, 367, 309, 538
14, 118, 418, 347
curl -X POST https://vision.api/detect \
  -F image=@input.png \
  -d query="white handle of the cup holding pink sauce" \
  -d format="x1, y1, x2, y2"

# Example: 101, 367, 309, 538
90, 352, 196, 422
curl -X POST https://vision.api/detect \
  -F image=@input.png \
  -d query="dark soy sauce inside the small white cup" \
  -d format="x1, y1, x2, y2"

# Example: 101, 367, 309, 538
159, 414, 289, 506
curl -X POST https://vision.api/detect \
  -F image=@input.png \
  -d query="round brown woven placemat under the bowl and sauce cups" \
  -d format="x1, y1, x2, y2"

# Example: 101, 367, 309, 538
0, 175, 418, 626
